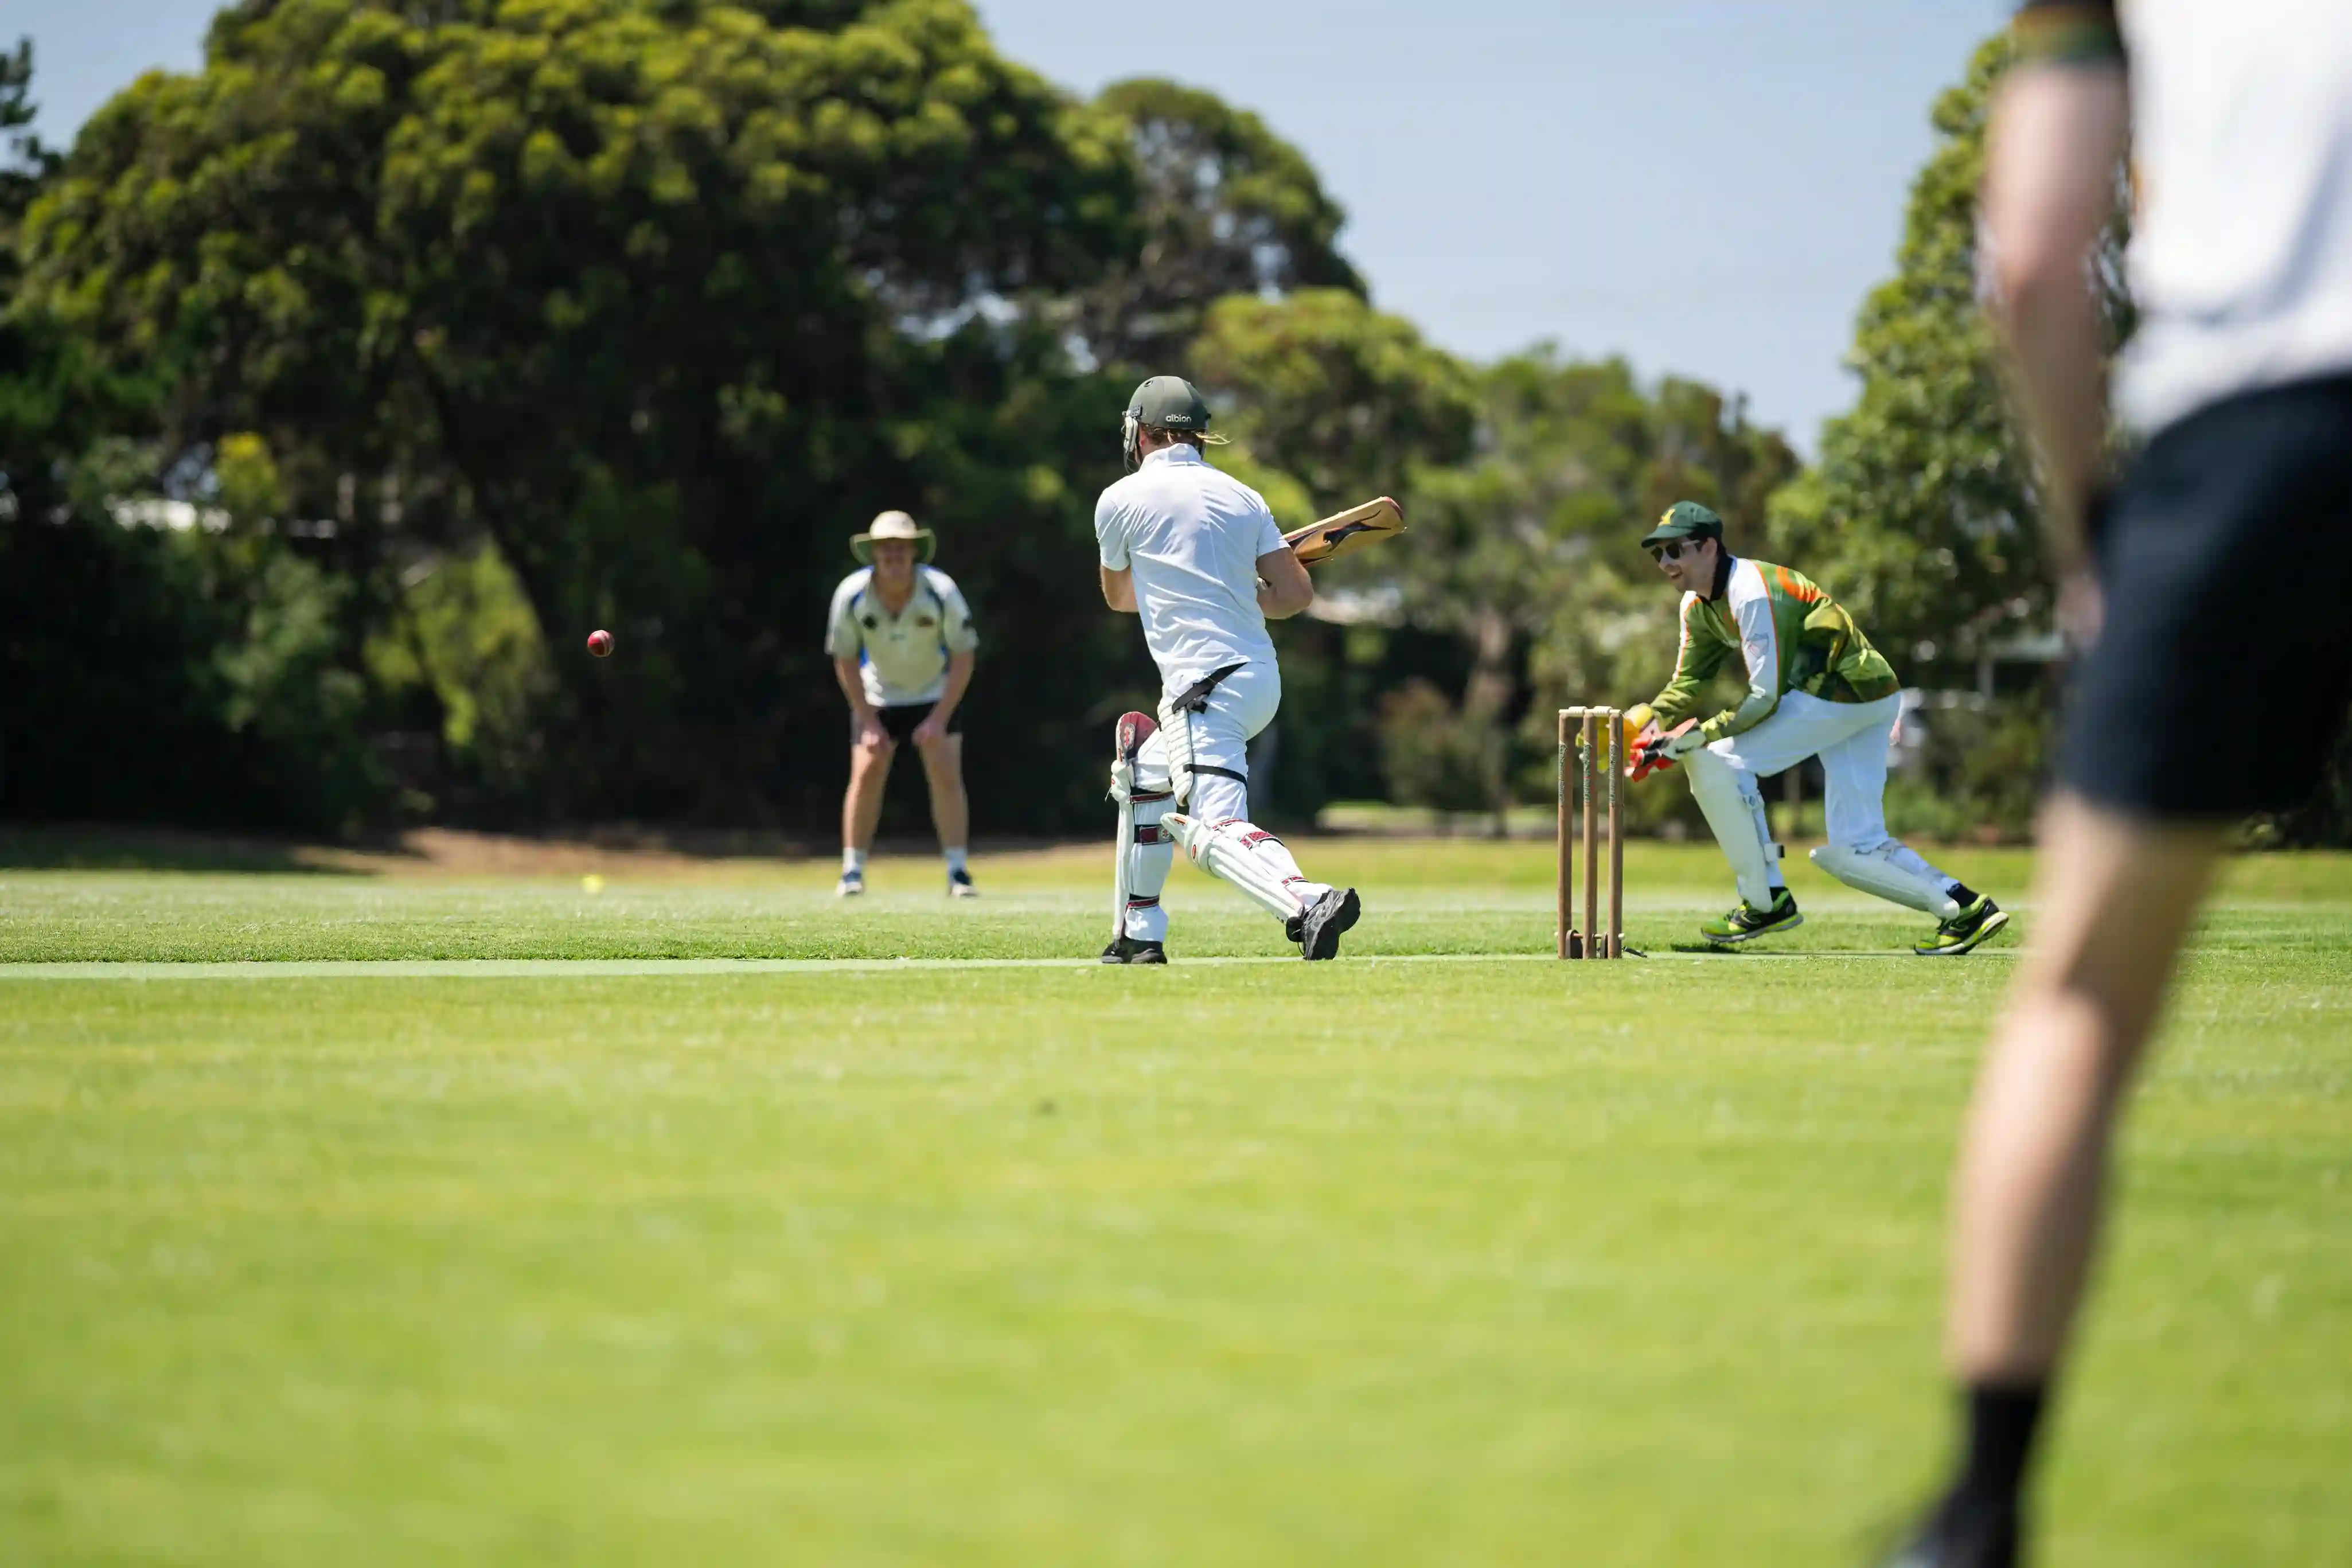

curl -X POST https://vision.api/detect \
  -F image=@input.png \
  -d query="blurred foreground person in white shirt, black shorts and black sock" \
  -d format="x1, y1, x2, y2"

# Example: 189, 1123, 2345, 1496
1889, 0, 2352, 1568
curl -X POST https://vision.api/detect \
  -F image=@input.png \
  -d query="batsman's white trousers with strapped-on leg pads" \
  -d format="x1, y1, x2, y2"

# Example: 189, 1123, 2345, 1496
1113, 665, 1331, 943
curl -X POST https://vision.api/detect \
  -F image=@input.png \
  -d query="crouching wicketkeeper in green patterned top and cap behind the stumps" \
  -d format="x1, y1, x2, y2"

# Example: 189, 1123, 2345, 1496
1625, 501, 2008, 957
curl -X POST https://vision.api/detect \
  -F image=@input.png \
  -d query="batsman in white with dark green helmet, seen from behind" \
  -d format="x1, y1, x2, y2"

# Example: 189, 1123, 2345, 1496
1094, 376, 1359, 964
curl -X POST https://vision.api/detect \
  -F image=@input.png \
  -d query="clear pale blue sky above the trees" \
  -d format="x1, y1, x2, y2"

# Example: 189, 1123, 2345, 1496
0, 0, 2011, 451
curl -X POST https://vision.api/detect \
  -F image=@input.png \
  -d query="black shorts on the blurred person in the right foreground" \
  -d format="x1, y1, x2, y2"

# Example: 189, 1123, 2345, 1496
2058, 376, 2352, 821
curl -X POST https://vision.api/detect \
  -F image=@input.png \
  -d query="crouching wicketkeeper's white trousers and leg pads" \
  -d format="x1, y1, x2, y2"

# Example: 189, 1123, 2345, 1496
1684, 691, 1959, 917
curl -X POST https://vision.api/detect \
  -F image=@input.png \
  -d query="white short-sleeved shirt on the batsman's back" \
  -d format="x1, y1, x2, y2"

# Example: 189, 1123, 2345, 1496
1094, 442, 1284, 691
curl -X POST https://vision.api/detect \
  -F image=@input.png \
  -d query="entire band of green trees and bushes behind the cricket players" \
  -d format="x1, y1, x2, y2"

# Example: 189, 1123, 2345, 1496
14, 12, 2352, 839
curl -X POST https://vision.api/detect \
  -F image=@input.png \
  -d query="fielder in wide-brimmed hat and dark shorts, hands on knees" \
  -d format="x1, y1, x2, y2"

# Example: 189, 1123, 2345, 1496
825, 513, 981, 898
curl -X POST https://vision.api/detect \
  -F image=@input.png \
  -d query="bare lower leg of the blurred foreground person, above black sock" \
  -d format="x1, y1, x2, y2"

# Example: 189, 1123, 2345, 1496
1950, 794, 2216, 1382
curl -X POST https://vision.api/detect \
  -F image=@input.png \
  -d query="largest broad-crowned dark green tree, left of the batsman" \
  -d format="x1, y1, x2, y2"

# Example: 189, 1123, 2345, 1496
26, 0, 1134, 821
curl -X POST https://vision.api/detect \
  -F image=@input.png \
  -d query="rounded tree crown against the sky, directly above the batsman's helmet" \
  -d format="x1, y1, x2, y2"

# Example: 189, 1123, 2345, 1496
1079, 77, 1364, 374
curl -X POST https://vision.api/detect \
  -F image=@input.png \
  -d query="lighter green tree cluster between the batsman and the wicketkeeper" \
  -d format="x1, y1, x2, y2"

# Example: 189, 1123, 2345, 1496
1192, 289, 1797, 825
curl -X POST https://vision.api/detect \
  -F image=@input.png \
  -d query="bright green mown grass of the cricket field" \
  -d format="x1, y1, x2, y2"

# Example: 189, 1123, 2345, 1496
0, 839, 2352, 1568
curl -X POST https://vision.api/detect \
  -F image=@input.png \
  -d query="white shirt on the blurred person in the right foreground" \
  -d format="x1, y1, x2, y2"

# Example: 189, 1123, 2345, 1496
2117, 0, 2352, 432
